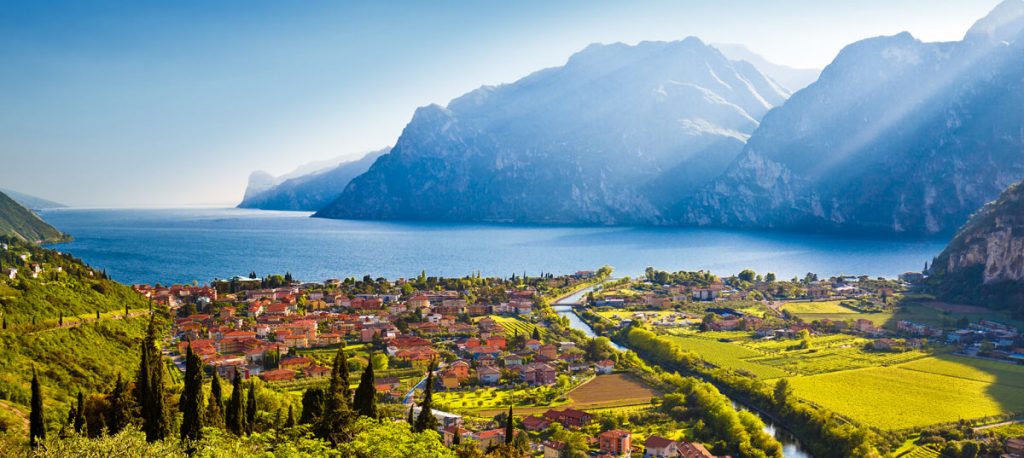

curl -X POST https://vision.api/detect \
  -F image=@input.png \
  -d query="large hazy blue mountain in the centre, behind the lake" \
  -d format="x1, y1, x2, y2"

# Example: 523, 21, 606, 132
315, 38, 790, 224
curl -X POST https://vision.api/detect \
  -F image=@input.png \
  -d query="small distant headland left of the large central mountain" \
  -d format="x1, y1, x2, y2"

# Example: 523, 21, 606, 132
239, 149, 387, 211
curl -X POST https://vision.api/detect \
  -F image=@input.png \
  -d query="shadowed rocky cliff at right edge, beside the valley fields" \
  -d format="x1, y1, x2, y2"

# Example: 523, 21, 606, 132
929, 183, 1024, 317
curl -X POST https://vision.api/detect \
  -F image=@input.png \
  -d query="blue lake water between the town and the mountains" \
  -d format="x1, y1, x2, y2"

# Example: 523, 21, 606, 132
43, 208, 945, 284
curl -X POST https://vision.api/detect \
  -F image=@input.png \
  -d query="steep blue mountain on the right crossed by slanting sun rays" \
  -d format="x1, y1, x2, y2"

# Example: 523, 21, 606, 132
675, 0, 1024, 234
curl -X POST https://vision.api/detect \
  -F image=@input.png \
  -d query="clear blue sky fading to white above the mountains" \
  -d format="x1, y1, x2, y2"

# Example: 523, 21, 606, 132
0, 0, 997, 206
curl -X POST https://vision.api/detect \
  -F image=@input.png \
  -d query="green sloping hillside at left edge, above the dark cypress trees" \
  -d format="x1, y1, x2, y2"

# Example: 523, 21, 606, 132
0, 241, 156, 438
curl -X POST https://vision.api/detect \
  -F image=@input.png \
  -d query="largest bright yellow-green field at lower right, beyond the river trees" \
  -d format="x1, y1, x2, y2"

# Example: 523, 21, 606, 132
790, 359, 1024, 429
